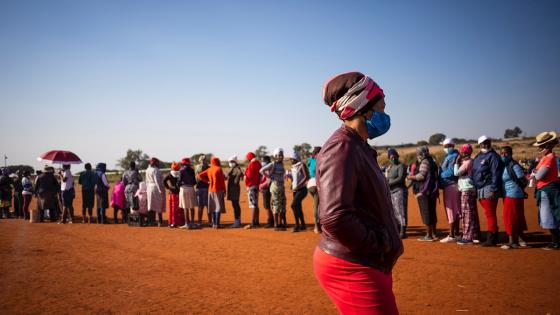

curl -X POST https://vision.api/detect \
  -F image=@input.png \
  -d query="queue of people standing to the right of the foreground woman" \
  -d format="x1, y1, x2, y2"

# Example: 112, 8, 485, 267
385, 131, 560, 250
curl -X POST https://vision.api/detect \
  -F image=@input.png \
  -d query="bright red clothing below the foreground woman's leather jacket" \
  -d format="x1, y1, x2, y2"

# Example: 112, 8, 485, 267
313, 248, 399, 315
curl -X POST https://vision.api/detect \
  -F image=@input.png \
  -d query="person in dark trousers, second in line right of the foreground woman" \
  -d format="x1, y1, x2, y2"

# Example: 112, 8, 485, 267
408, 146, 439, 242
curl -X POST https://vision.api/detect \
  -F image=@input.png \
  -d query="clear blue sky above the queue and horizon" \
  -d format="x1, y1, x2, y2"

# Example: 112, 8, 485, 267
0, 0, 560, 169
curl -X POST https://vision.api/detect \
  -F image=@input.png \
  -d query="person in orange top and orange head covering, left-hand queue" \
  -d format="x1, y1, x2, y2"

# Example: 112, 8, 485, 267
198, 157, 226, 229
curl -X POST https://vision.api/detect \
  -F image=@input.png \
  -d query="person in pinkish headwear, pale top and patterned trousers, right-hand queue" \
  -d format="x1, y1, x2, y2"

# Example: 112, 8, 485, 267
453, 143, 480, 245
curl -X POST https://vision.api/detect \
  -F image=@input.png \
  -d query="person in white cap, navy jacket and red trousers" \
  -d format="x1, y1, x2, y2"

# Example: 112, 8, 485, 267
473, 135, 504, 247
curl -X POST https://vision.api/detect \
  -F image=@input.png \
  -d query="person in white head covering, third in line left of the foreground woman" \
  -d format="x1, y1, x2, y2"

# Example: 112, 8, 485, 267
260, 148, 286, 231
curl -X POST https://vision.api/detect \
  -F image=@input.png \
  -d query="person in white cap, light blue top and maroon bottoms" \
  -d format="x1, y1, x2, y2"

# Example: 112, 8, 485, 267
439, 138, 461, 243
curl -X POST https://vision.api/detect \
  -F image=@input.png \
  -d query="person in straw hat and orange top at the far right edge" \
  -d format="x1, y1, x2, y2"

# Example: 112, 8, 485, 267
531, 131, 560, 250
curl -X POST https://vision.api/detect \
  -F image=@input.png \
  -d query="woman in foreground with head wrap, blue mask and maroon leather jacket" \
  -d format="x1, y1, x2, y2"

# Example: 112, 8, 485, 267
313, 72, 403, 314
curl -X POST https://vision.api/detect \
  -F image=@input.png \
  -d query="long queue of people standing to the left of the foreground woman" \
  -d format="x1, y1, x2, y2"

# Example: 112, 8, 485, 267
0, 147, 321, 233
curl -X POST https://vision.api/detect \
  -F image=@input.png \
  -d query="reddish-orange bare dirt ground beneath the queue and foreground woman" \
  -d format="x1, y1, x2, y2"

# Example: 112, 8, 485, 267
0, 184, 560, 314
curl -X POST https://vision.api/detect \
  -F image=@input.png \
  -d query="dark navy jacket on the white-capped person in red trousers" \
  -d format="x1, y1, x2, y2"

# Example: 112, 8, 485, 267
473, 149, 504, 193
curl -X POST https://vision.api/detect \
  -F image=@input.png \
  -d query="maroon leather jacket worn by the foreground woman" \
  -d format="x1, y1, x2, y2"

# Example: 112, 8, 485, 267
316, 126, 403, 273
